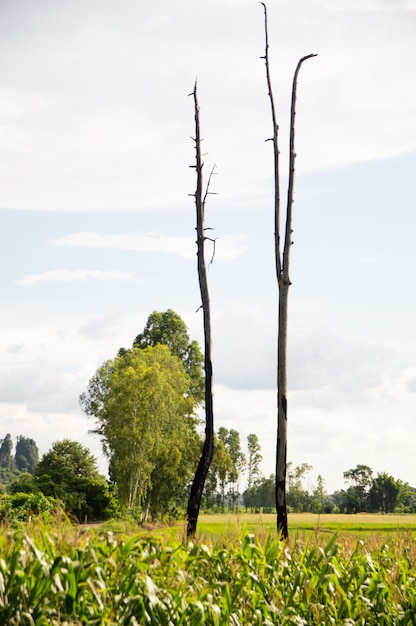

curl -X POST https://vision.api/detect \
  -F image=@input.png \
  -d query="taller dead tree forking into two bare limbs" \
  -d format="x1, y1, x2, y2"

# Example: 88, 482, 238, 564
261, 2, 316, 539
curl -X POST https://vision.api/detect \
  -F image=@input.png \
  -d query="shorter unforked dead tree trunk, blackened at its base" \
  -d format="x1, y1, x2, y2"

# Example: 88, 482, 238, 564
186, 83, 215, 537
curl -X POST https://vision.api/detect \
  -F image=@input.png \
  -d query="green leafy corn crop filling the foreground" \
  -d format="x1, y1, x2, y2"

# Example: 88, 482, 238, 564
0, 518, 416, 626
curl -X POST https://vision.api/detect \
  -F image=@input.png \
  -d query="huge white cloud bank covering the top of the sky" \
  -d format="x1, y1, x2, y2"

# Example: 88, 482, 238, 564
0, 0, 416, 212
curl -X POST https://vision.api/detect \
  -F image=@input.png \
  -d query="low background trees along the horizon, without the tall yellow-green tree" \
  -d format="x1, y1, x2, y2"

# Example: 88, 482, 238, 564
0, 427, 416, 521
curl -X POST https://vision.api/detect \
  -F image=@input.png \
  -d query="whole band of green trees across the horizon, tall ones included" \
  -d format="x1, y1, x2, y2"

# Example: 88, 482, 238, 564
0, 309, 416, 521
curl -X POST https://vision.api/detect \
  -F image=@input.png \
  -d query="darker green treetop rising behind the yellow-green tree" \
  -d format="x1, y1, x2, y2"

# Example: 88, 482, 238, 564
133, 309, 205, 404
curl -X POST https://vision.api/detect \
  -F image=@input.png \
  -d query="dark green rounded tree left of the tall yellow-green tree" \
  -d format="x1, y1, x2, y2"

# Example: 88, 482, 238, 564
35, 439, 111, 519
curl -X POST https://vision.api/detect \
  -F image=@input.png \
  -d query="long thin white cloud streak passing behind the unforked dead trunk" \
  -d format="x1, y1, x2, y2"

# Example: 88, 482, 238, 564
50, 232, 247, 261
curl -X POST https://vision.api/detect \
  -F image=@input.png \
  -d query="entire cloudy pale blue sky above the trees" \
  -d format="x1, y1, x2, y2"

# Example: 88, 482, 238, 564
0, 0, 416, 492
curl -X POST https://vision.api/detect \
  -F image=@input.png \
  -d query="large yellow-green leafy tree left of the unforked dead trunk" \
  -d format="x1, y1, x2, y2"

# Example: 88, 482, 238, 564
80, 343, 197, 516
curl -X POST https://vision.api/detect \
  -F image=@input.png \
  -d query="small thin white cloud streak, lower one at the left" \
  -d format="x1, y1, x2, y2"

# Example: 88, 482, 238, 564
14, 269, 137, 287
